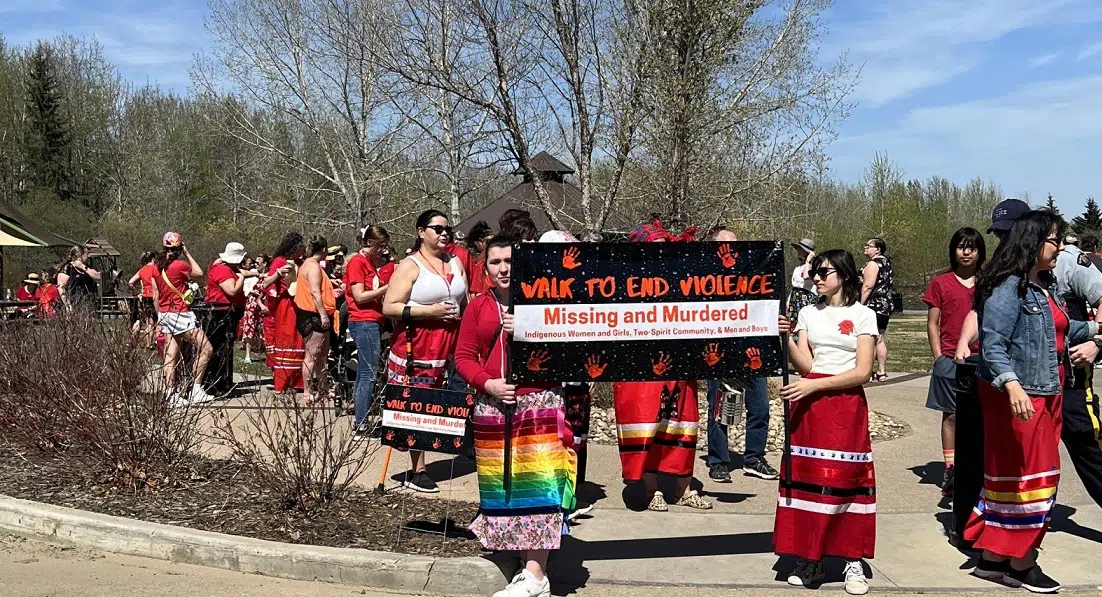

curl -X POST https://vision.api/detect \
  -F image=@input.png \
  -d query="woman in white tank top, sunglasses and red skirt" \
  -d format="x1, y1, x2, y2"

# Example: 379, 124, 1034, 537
382, 209, 467, 493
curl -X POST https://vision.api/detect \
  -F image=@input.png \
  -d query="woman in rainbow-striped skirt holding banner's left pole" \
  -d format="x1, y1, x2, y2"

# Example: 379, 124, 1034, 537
455, 237, 575, 597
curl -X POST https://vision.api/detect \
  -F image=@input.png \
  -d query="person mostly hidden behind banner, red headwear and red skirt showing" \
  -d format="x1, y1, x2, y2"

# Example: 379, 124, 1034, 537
613, 220, 712, 512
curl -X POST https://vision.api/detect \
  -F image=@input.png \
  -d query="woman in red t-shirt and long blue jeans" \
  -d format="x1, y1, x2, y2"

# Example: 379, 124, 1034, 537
344, 226, 395, 433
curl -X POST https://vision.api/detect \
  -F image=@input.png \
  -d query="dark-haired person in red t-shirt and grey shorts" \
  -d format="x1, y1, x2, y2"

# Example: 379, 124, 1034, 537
922, 228, 987, 498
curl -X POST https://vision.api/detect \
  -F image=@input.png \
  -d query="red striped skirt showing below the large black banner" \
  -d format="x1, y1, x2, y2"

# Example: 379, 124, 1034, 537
613, 381, 700, 481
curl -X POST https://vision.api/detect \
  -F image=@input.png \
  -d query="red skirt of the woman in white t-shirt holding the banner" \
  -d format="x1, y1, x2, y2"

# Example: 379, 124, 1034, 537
773, 373, 876, 560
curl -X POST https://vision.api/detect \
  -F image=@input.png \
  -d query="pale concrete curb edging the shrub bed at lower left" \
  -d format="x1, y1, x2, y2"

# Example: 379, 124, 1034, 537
0, 496, 506, 595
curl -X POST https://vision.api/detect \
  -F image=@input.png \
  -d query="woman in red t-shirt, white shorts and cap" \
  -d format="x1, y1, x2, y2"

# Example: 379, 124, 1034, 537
153, 232, 214, 405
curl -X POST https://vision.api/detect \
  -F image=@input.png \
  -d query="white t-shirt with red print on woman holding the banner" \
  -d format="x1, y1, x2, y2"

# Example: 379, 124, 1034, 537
796, 303, 877, 376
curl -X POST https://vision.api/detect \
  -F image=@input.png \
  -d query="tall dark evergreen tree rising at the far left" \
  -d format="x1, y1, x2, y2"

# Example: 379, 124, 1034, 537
26, 42, 72, 200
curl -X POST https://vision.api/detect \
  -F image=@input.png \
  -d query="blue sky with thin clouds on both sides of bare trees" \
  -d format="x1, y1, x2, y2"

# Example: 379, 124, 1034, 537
0, 0, 1102, 214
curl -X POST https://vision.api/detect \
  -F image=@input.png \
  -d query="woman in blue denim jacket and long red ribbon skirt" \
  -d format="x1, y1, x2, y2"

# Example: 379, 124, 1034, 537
964, 210, 1098, 593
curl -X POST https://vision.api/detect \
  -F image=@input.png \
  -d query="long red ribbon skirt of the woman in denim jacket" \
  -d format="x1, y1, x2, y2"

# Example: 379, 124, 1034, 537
964, 381, 1063, 557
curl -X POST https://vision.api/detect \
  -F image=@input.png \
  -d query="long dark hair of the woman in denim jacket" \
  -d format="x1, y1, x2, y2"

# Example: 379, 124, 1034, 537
974, 209, 1068, 311
